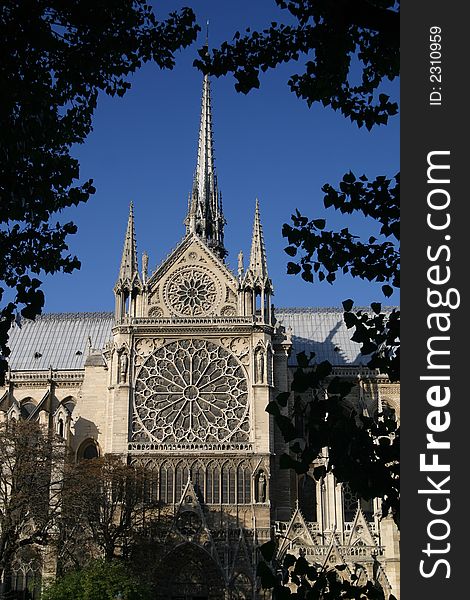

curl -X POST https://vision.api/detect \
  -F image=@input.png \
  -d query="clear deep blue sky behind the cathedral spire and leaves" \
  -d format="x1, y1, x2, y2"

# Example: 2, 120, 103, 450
42, 0, 399, 312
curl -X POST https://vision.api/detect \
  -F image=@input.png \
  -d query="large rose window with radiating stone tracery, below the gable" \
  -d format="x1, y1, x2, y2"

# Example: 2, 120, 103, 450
132, 340, 249, 443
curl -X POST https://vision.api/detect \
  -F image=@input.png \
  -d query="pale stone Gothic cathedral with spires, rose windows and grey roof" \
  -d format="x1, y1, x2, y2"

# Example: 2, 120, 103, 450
0, 76, 399, 600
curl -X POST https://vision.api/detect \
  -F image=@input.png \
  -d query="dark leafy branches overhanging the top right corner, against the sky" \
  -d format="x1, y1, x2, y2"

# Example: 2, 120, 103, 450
195, 0, 400, 129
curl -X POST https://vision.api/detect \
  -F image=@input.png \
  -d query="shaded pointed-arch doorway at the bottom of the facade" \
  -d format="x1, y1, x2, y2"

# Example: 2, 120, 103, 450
156, 543, 225, 600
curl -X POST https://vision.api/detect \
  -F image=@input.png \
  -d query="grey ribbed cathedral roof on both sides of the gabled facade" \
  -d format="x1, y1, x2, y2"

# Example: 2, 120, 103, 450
9, 308, 392, 371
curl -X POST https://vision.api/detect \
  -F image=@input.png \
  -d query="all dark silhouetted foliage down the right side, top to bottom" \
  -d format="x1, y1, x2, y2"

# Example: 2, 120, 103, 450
195, 0, 400, 599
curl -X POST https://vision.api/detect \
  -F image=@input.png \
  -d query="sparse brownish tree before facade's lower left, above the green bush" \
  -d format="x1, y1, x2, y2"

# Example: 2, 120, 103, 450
56, 454, 166, 572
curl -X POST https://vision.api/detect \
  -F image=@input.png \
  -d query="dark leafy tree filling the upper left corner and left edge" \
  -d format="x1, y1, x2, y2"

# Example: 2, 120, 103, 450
0, 0, 199, 380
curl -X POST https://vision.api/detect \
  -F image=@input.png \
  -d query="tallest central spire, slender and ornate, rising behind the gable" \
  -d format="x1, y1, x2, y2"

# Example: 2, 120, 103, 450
185, 75, 227, 258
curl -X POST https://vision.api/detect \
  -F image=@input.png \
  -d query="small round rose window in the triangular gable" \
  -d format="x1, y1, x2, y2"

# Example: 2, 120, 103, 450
164, 269, 218, 317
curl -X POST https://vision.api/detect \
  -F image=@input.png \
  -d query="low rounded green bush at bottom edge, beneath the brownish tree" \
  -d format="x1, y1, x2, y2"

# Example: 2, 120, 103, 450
42, 560, 152, 600
